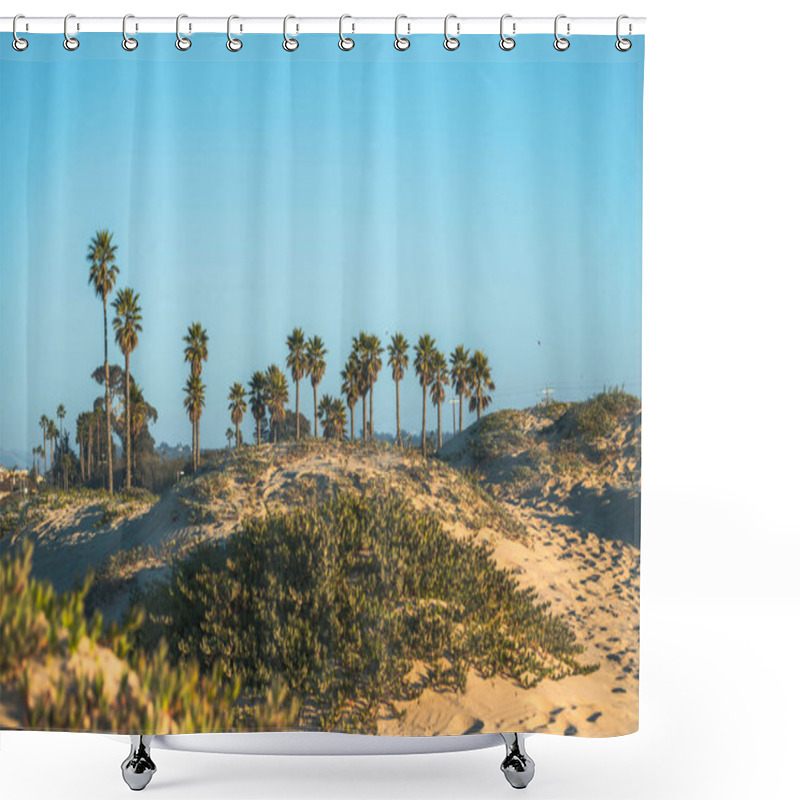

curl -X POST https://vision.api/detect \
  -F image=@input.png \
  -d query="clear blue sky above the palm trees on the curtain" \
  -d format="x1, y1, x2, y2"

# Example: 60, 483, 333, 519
0, 34, 644, 462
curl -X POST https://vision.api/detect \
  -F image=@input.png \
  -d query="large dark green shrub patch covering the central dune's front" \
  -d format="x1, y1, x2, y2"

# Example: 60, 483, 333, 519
134, 494, 594, 733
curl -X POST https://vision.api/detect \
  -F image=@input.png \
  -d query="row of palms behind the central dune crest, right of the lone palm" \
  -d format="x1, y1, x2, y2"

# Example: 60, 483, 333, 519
222, 328, 495, 455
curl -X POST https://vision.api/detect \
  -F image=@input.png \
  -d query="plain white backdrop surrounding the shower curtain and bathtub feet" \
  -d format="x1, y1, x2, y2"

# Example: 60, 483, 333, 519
0, 0, 800, 800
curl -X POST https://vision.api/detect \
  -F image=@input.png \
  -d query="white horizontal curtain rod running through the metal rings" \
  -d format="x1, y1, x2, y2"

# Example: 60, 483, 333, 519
0, 15, 645, 35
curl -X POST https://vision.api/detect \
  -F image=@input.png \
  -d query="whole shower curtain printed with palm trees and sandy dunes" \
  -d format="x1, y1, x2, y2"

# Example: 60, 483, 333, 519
0, 26, 644, 736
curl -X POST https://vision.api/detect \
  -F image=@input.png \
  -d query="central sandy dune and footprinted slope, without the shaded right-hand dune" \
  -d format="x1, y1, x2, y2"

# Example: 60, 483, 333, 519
0, 424, 639, 736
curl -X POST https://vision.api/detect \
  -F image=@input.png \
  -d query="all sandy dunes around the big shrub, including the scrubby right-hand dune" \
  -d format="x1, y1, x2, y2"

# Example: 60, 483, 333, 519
0, 396, 640, 735
